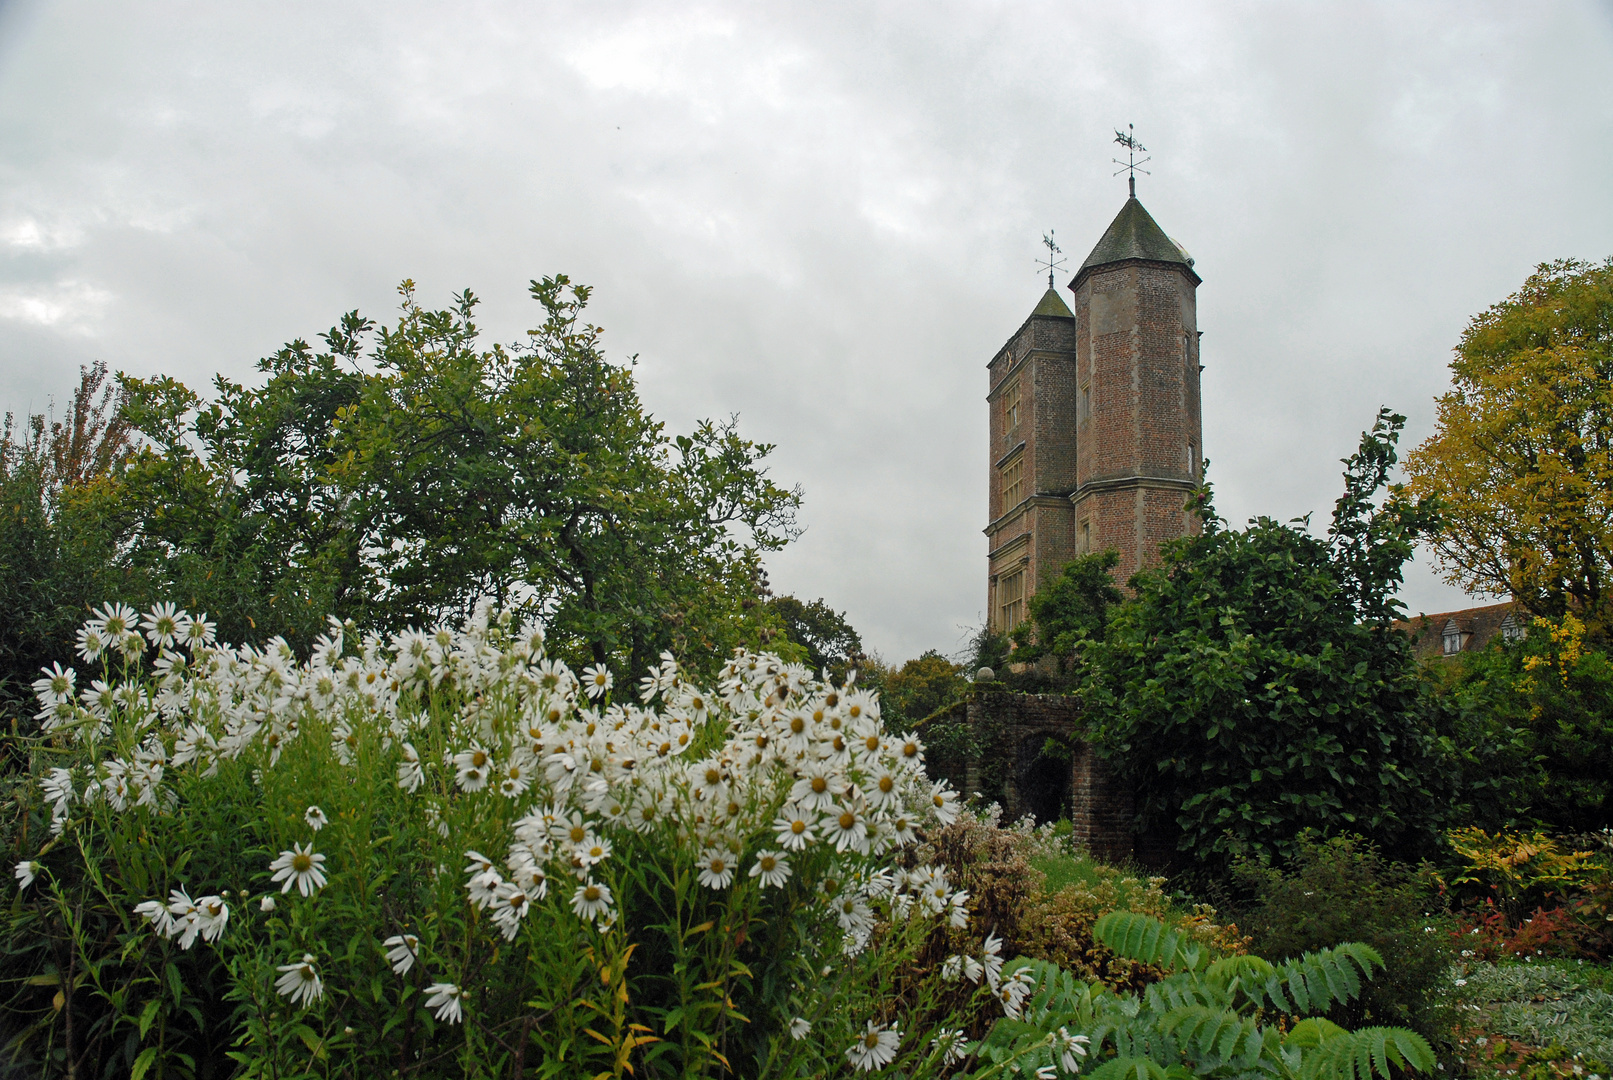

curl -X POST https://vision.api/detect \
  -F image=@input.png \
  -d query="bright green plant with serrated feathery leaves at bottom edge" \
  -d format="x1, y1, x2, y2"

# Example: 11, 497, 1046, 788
971, 911, 1434, 1080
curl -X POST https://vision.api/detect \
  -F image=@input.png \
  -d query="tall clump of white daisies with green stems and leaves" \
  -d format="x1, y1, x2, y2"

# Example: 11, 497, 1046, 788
5, 604, 993, 1077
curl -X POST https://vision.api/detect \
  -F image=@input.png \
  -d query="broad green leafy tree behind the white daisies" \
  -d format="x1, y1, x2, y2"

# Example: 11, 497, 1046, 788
110, 276, 800, 671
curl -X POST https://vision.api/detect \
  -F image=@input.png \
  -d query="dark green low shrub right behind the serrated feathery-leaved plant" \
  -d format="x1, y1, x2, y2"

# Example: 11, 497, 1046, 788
1234, 833, 1455, 1045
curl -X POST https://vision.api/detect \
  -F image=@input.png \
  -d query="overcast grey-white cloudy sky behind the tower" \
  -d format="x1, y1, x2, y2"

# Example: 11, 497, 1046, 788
0, 0, 1613, 661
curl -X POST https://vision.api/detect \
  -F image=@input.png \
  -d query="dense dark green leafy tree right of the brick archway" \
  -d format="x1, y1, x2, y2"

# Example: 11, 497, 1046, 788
1082, 409, 1442, 867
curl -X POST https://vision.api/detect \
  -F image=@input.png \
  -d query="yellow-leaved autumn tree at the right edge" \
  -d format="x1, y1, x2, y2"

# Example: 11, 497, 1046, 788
1407, 260, 1613, 640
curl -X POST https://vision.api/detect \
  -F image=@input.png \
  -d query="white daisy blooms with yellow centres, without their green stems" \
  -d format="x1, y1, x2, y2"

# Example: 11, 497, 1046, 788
18, 604, 967, 1044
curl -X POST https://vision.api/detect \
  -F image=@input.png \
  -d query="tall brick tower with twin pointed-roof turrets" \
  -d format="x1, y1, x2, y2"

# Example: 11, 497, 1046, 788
986, 197, 1203, 632
